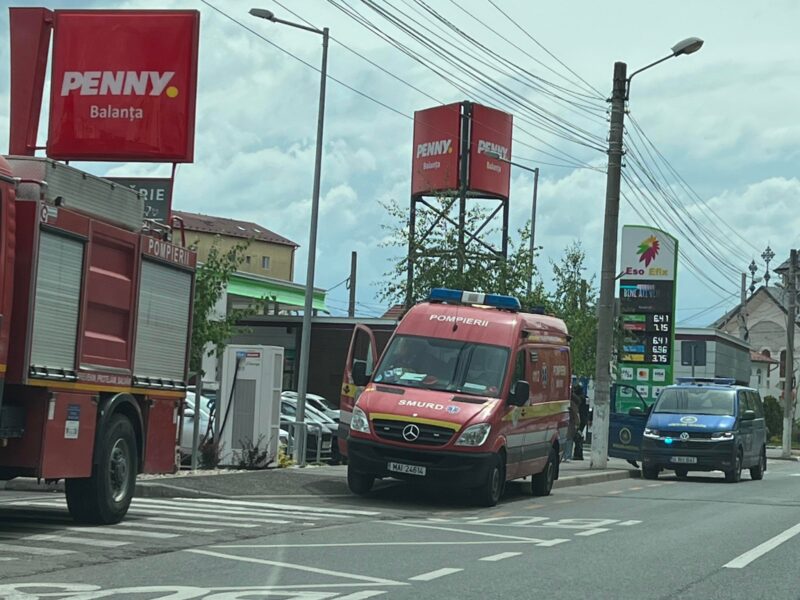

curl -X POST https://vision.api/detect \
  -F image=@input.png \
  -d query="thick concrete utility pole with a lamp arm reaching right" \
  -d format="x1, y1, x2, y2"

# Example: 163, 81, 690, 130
590, 37, 703, 469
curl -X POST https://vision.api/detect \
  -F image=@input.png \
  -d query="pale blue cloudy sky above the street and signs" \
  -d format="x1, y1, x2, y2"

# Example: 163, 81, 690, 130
0, 0, 800, 326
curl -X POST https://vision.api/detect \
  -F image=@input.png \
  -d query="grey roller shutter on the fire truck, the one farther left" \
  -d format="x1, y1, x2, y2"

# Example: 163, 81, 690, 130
30, 230, 84, 371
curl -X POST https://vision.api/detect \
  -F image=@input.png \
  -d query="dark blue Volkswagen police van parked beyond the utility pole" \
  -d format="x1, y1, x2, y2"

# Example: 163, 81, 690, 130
628, 378, 767, 483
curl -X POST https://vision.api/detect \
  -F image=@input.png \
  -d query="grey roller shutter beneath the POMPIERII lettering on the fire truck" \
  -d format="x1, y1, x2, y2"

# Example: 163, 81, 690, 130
133, 260, 192, 383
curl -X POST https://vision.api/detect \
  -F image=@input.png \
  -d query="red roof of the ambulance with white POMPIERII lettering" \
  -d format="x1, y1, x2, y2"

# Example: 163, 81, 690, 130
397, 302, 568, 345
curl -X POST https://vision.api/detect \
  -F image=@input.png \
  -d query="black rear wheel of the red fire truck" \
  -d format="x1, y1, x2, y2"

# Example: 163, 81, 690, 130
65, 415, 138, 525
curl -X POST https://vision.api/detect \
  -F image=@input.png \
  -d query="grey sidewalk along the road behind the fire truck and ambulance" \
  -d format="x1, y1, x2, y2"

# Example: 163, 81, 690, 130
5, 449, 639, 498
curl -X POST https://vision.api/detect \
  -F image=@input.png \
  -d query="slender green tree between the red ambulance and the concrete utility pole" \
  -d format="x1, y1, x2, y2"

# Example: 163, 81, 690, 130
551, 242, 598, 375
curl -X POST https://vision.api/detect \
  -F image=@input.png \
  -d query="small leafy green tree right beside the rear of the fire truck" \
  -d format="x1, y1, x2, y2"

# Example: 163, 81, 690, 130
189, 240, 258, 373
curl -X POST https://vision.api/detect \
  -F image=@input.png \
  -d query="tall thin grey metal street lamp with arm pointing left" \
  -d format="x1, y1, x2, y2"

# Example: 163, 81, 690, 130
250, 8, 328, 467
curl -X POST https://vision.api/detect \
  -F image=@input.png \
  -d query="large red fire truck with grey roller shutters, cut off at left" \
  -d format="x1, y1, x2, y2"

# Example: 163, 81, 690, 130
0, 156, 196, 523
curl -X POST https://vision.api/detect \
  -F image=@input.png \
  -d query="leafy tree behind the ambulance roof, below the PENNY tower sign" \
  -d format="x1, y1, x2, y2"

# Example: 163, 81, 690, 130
378, 198, 546, 305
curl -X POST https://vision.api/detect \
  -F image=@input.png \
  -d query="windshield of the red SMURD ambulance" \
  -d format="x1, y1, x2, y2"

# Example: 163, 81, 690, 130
373, 335, 509, 396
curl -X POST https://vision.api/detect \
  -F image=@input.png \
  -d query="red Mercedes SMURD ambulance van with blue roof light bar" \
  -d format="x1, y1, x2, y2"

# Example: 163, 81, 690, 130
340, 289, 571, 506
